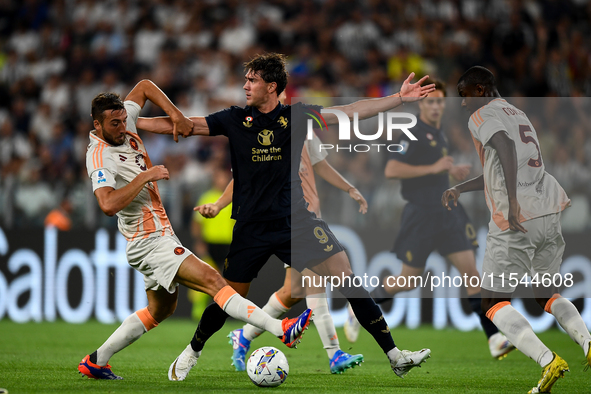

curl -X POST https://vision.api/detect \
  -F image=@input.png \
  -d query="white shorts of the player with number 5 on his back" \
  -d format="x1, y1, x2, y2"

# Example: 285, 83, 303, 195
481, 213, 564, 293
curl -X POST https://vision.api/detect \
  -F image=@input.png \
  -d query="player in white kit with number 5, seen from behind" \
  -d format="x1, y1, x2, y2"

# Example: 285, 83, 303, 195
442, 66, 591, 393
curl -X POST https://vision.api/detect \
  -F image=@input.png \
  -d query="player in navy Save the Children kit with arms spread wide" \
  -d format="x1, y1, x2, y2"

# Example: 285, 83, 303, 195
138, 53, 434, 380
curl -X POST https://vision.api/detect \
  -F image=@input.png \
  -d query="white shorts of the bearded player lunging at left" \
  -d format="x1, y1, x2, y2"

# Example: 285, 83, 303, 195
126, 235, 193, 294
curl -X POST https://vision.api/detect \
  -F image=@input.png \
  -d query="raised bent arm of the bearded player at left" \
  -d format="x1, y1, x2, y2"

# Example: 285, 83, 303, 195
125, 79, 193, 142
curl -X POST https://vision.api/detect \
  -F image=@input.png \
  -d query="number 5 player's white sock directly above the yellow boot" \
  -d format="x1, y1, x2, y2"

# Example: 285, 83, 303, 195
486, 302, 554, 367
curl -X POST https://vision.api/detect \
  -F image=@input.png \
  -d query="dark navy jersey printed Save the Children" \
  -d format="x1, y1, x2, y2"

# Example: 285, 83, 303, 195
205, 103, 321, 221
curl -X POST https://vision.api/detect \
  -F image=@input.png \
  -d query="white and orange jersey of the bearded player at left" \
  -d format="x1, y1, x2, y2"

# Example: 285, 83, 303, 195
86, 101, 174, 241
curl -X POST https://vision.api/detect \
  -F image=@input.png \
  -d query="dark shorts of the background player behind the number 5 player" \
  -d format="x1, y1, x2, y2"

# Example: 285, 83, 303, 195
392, 203, 478, 268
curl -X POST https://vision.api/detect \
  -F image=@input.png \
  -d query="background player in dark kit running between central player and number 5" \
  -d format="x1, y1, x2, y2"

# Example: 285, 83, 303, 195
345, 79, 515, 359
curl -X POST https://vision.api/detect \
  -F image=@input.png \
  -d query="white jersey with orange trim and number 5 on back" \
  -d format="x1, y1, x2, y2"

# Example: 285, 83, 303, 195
468, 98, 570, 231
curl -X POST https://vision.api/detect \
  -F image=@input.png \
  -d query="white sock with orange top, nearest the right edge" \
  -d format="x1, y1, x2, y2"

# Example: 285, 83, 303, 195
546, 297, 591, 356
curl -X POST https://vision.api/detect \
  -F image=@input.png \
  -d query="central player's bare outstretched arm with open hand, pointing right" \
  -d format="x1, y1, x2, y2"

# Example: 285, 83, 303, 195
322, 73, 435, 124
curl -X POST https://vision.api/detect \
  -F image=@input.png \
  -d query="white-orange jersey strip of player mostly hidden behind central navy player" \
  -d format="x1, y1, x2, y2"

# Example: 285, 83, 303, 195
299, 134, 328, 217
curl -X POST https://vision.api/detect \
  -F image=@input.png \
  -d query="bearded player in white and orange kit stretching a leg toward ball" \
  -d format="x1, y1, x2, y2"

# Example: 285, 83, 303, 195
78, 80, 311, 380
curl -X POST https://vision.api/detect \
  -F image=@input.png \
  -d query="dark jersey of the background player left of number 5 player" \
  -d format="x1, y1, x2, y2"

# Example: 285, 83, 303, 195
389, 119, 449, 205
